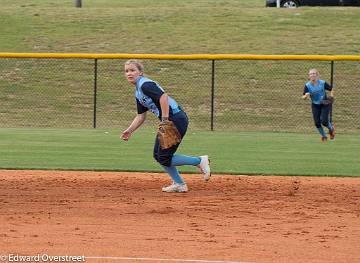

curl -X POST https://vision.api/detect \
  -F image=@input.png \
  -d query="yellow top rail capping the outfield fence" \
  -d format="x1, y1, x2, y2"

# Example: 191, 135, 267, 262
0, 52, 360, 61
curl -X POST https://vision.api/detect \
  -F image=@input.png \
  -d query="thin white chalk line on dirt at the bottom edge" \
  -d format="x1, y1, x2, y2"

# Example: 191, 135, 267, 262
85, 256, 251, 263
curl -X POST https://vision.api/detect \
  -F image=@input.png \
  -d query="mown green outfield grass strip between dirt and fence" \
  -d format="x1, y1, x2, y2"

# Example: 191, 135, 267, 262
0, 129, 360, 176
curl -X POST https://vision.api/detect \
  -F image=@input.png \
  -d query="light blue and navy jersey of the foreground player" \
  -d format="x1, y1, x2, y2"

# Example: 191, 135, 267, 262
135, 76, 181, 119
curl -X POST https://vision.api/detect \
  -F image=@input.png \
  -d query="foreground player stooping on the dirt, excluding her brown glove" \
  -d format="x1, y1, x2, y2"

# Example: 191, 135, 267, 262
121, 60, 211, 193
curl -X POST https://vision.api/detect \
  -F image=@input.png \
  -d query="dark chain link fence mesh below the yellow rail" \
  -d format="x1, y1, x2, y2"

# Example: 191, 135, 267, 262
0, 57, 360, 133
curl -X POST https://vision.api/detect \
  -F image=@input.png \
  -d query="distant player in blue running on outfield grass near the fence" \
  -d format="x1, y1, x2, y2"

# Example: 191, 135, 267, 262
302, 69, 335, 142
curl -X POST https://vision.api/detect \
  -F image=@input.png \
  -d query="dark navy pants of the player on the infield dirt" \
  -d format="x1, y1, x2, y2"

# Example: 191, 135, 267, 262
153, 111, 189, 167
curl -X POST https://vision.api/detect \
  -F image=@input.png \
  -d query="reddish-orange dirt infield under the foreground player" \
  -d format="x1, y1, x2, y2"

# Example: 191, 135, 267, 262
0, 170, 360, 263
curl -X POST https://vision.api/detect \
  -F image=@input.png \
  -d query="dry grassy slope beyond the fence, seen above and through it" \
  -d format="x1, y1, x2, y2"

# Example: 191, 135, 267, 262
0, 0, 360, 133
